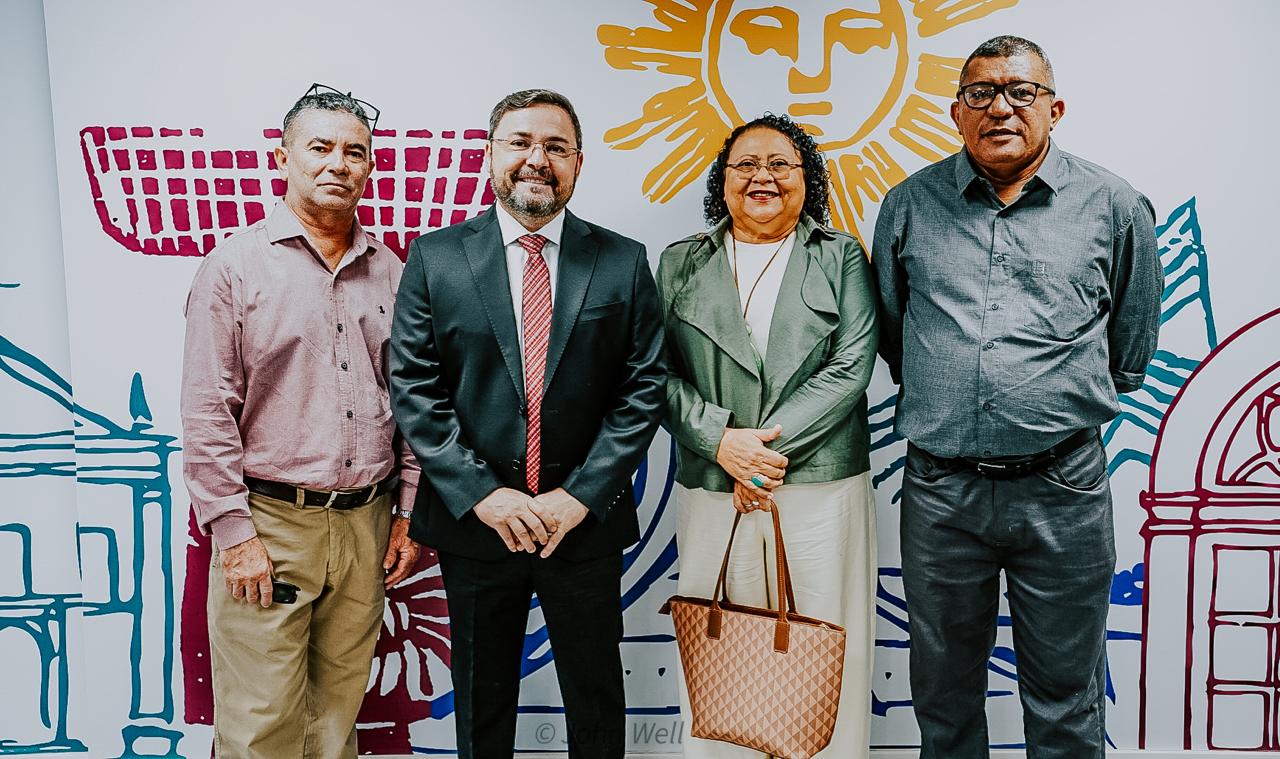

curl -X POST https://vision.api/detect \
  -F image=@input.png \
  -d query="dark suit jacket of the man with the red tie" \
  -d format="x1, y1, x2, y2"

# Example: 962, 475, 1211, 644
390, 209, 666, 561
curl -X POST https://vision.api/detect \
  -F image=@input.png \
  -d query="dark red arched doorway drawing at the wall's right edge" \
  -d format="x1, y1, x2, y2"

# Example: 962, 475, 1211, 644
1139, 304, 1280, 751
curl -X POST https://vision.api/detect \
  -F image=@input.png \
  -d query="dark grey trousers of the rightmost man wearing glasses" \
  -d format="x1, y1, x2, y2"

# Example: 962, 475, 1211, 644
901, 432, 1115, 759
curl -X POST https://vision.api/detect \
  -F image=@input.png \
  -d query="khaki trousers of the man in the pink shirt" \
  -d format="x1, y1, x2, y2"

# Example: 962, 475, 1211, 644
209, 493, 392, 759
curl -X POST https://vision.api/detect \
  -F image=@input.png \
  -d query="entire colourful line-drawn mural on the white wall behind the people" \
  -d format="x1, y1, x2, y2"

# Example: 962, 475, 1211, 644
10, 0, 1280, 759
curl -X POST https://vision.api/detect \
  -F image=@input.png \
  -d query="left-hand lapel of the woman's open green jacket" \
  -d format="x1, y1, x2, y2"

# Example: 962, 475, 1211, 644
671, 223, 760, 379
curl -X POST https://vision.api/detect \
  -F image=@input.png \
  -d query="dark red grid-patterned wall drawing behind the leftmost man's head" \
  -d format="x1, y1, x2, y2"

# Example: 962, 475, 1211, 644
81, 127, 493, 257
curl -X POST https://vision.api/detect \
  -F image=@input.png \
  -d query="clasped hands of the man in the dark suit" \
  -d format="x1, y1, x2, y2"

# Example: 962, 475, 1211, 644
474, 488, 586, 558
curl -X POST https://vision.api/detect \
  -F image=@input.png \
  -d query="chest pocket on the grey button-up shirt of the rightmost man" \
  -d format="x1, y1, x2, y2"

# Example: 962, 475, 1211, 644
1014, 259, 1098, 342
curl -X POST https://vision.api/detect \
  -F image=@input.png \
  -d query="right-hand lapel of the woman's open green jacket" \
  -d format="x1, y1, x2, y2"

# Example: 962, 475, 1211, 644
763, 216, 840, 416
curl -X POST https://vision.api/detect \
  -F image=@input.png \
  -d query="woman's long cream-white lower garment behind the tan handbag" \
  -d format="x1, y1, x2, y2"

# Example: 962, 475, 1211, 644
676, 472, 878, 759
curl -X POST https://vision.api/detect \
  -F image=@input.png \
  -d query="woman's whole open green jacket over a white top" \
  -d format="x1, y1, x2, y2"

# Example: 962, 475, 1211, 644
658, 216, 877, 493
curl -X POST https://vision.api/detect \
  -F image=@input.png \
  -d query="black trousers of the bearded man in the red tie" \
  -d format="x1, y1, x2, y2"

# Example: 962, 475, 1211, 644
439, 552, 626, 759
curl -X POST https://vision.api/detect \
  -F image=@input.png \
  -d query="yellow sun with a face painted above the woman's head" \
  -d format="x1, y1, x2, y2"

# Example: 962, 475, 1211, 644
596, 0, 1018, 237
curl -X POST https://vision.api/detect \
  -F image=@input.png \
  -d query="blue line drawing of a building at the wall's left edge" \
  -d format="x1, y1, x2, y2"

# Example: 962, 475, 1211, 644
0, 335, 183, 759
